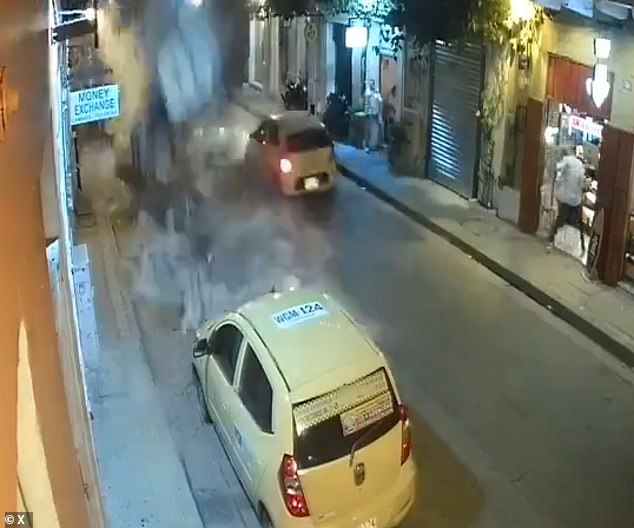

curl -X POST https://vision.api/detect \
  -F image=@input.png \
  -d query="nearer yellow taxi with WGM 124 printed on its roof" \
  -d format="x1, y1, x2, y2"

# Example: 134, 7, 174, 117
193, 289, 416, 528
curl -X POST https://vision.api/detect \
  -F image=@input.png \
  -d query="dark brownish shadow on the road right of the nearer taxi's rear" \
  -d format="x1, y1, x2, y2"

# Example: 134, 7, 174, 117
400, 409, 485, 528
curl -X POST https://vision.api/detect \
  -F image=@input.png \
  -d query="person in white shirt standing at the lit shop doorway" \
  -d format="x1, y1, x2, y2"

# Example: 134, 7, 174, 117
549, 147, 586, 252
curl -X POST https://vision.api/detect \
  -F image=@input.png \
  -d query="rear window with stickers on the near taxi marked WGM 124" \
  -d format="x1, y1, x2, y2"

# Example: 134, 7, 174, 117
293, 368, 399, 469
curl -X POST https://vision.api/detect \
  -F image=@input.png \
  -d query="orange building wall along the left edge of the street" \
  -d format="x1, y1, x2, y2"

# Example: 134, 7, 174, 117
0, 0, 104, 528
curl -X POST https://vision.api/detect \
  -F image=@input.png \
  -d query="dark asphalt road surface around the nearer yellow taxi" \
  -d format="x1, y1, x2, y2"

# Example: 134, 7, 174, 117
112, 104, 634, 528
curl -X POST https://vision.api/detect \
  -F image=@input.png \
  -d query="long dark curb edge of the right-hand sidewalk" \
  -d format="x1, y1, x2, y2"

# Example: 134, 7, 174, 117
337, 163, 634, 368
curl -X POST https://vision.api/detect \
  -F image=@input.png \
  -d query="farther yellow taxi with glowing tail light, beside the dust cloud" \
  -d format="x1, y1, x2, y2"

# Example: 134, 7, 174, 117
246, 111, 338, 196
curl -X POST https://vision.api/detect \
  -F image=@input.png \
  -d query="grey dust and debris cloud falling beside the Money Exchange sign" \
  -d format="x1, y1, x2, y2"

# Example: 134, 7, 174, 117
82, 0, 330, 332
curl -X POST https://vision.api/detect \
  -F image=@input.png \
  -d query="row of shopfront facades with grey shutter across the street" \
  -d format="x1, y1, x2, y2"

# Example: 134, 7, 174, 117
250, 0, 634, 286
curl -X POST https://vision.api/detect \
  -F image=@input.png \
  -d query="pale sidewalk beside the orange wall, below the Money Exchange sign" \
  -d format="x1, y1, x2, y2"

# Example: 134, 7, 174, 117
73, 137, 203, 528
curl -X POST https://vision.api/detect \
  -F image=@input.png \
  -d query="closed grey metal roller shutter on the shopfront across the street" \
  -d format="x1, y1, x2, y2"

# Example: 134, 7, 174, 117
427, 43, 484, 198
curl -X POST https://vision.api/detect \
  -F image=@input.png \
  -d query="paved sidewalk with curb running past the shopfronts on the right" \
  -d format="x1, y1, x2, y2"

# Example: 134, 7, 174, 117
237, 88, 634, 367
